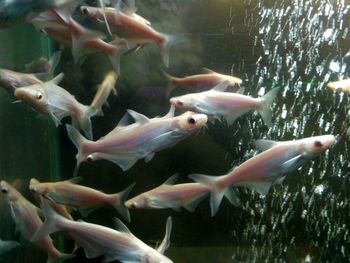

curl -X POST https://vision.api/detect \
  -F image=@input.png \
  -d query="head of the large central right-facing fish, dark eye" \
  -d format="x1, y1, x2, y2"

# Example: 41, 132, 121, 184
172, 111, 208, 132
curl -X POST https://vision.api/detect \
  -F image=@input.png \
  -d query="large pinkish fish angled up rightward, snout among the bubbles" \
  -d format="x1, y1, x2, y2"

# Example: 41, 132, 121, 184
189, 135, 335, 216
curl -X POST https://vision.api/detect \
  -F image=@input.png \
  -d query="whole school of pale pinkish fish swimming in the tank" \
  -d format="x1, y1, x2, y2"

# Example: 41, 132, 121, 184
0, 0, 340, 263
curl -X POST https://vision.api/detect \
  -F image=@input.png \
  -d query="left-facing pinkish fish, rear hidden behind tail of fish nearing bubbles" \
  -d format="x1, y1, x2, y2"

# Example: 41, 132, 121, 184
125, 174, 210, 212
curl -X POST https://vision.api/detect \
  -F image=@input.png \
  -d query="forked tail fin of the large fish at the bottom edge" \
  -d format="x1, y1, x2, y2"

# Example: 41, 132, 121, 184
30, 197, 69, 242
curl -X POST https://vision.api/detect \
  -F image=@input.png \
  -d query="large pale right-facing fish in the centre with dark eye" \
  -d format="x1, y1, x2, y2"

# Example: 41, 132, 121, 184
66, 107, 208, 174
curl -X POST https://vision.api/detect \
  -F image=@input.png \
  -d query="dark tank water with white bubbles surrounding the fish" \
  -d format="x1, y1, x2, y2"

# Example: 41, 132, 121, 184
0, 0, 350, 263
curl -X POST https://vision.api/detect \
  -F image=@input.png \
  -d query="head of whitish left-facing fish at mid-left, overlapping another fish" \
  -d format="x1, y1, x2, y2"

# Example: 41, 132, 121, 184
15, 85, 48, 112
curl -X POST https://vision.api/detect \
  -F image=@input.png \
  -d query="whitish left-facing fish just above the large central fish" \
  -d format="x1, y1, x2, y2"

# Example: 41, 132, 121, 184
169, 81, 279, 127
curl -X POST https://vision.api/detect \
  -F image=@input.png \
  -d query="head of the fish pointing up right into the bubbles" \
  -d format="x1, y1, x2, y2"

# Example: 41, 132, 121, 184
303, 135, 335, 155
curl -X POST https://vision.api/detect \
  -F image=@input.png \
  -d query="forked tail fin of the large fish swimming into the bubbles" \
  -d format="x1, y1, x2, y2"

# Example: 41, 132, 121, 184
189, 174, 228, 216
